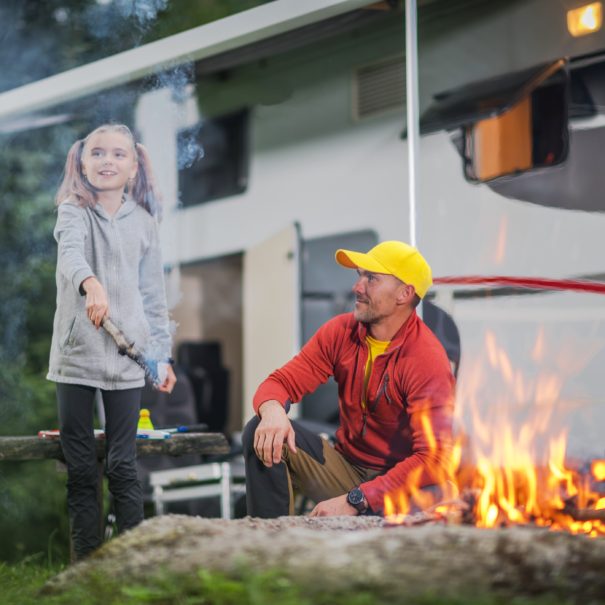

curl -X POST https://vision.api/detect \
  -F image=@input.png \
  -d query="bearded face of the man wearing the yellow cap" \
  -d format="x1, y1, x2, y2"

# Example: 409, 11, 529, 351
353, 269, 412, 324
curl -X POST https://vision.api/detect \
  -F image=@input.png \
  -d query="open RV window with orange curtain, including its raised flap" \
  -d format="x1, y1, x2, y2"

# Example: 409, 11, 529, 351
420, 59, 572, 182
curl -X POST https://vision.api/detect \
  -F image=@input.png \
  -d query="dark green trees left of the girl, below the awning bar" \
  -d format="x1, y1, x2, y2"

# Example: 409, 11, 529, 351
0, 130, 79, 560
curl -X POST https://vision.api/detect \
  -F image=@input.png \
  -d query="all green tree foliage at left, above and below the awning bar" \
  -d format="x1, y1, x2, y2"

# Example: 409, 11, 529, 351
0, 0, 266, 561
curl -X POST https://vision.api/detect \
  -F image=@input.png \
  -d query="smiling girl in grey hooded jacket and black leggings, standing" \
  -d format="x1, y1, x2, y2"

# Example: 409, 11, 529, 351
47, 124, 176, 559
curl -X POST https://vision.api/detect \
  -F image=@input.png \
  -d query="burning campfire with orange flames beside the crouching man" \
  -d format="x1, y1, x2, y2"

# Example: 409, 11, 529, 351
385, 332, 605, 537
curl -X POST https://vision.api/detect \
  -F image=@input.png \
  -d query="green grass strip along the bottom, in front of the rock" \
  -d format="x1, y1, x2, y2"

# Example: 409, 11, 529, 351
0, 558, 562, 605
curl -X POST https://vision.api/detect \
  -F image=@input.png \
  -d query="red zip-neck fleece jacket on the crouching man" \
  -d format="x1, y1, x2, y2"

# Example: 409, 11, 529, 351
254, 312, 454, 512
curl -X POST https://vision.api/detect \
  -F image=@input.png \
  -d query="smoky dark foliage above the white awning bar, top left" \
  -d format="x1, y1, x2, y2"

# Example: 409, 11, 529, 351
0, 0, 269, 91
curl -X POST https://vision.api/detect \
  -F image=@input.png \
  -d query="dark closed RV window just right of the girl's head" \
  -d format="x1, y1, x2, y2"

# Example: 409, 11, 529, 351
177, 110, 248, 206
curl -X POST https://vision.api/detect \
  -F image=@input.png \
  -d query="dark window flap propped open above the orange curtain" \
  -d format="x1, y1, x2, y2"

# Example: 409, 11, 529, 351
420, 59, 567, 134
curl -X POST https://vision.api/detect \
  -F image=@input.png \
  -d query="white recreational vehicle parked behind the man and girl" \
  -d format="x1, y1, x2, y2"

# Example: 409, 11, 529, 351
130, 0, 605, 457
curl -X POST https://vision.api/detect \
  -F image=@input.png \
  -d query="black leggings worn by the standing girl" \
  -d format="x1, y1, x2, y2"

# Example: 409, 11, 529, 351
57, 383, 143, 559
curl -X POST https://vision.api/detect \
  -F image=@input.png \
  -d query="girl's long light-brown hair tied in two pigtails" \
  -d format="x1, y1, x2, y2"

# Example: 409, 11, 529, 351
55, 124, 162, 219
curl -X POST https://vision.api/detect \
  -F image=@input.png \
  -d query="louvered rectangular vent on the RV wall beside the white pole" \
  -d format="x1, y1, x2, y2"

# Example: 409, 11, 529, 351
353, 57, 405, 120
